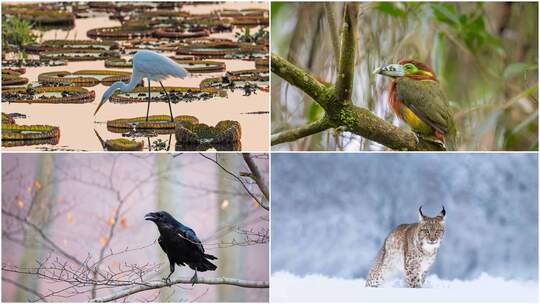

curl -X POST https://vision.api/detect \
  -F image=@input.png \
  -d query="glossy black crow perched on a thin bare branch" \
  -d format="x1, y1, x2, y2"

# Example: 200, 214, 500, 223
144, 211, 217, 285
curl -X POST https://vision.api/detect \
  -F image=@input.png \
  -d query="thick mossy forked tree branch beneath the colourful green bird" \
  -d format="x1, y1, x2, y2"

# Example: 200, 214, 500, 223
271, 3, 443, 151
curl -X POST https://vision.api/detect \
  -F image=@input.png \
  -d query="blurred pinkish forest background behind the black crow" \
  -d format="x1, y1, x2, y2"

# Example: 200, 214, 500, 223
2, 154, 269, 302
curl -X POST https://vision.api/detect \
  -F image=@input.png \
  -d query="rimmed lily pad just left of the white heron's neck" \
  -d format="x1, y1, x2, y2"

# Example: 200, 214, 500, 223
38, 70, 131, 87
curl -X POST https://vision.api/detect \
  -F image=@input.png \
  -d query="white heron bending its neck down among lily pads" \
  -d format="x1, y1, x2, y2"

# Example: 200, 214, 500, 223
94, 51, 188, 122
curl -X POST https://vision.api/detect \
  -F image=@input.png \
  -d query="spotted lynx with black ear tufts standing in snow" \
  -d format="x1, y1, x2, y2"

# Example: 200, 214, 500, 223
366, 206, 446, 288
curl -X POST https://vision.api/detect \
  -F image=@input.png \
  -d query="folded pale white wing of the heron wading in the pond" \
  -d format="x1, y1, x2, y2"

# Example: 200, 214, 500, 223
133, 51, 187, 81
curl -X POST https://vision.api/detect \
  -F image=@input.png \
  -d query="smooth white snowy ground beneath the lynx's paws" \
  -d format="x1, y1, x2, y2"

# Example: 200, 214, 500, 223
270, 272, 538, 302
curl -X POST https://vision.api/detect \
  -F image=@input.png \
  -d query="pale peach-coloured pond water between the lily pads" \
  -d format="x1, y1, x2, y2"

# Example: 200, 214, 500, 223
2, 2, 270, 151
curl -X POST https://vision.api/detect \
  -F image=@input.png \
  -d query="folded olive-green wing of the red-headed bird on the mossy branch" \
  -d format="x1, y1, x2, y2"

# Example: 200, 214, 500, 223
396, 77, 452, 133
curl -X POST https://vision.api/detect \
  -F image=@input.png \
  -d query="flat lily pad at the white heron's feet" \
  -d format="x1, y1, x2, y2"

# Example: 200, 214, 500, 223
107, 115, 199, 134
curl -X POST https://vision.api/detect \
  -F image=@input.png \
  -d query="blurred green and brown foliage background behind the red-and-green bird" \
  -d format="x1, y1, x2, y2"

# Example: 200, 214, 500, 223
271, 2, 538, 151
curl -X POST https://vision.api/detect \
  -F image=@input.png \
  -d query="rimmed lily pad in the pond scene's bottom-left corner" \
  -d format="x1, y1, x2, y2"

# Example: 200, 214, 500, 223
2, 123, 60, 145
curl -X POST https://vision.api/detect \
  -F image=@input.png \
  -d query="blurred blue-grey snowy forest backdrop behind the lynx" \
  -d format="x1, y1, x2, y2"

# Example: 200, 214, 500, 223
271, 153, 538, 280
